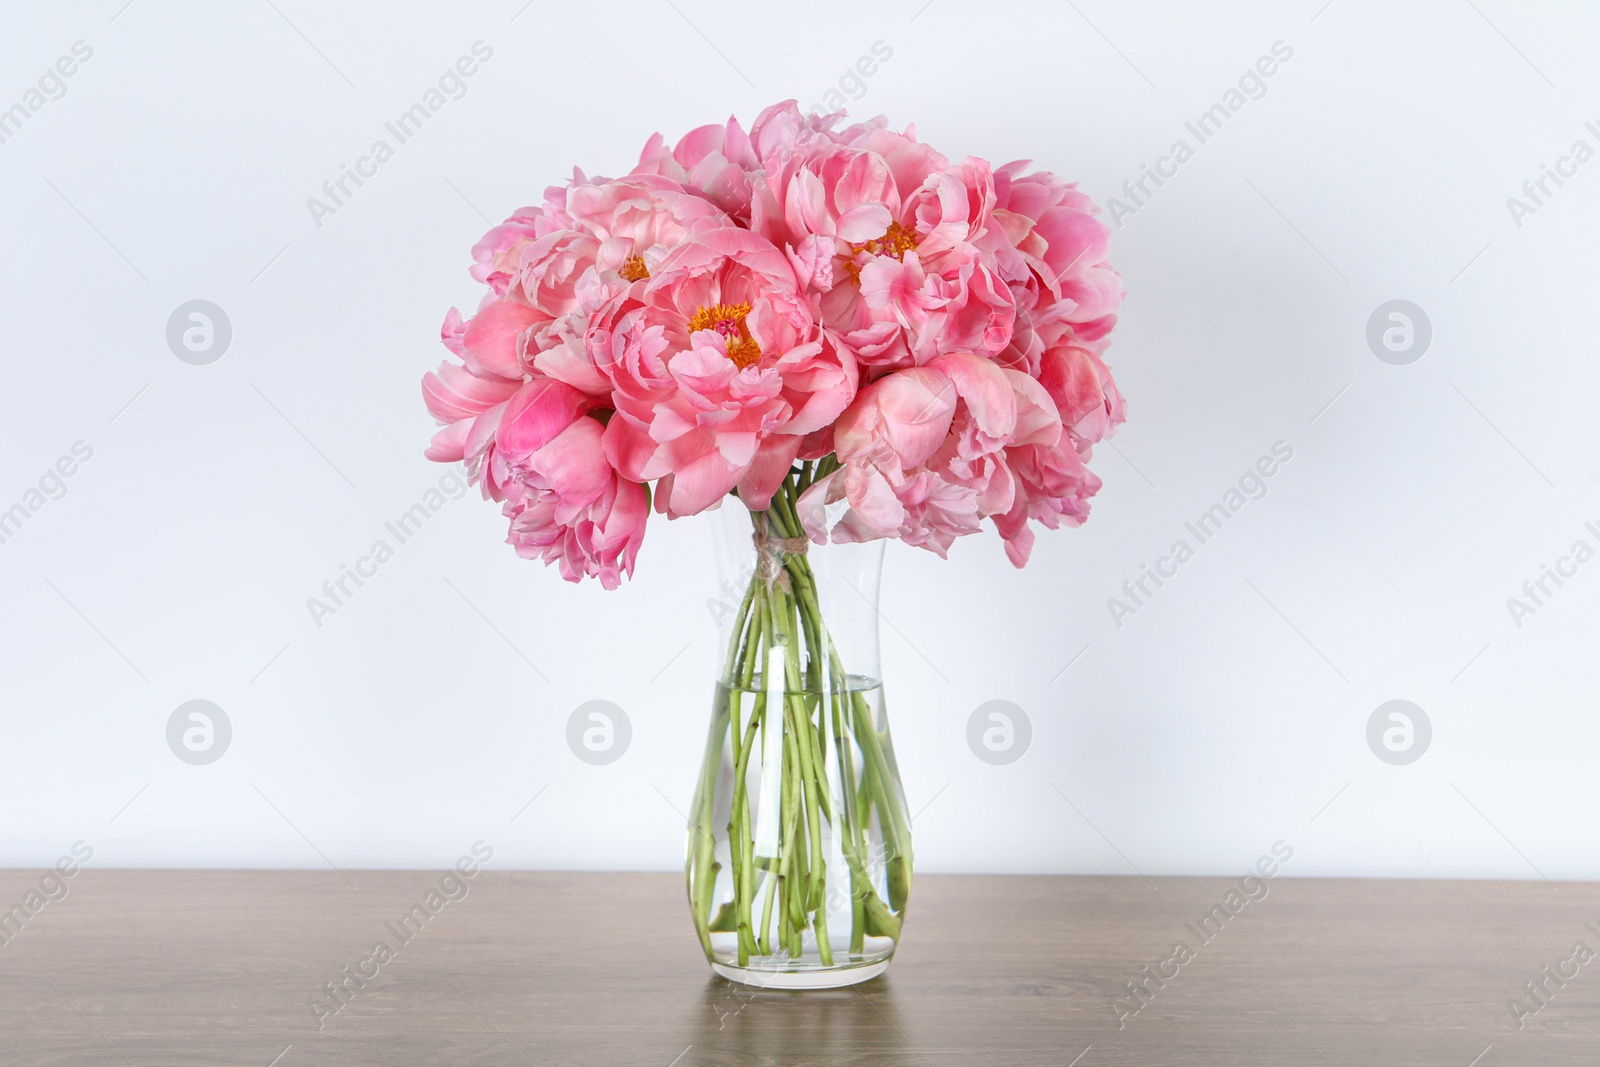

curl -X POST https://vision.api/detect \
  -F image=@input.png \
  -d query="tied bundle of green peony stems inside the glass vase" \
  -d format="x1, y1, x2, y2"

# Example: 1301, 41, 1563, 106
688, 470, 910, 966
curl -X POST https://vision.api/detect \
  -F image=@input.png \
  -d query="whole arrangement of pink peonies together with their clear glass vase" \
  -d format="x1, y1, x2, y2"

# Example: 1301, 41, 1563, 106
422, 101, 1123, 985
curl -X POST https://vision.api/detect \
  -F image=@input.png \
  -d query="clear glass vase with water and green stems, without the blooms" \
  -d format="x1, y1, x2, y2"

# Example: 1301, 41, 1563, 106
686, 486, 912, 989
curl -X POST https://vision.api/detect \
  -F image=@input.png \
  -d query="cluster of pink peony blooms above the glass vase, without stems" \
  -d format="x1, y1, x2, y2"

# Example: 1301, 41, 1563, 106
422, 101, 1123, 589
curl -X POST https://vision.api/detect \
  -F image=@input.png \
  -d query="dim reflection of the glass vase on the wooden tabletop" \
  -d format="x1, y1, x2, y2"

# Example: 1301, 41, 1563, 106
685, 977, 917, 1067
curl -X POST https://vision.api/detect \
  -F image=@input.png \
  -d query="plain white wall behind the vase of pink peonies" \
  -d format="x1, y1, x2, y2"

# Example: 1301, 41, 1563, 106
0, 0, 1600, 878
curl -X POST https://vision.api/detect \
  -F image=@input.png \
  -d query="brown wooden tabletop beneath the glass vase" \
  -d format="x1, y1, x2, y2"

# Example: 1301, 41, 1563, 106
0, 869, 1600, 1067
